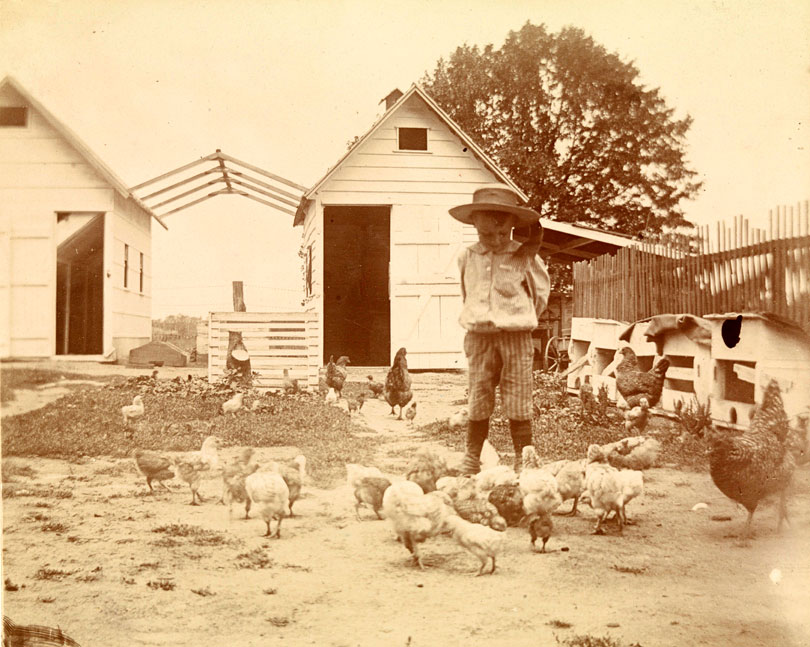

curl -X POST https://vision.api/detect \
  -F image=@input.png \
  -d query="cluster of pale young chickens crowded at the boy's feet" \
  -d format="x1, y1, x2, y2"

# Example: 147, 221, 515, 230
346, 438, 654, 575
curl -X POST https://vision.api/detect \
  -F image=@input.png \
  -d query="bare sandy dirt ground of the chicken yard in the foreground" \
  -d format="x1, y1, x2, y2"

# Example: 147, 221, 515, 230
3, 366, 810, 647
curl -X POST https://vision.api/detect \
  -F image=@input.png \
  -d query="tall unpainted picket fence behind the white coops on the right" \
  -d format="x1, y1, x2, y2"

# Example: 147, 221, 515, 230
573, 201, 810, 332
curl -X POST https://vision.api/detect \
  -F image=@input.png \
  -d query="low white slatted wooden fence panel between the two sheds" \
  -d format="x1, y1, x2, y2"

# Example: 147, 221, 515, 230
208, 312, 320, 390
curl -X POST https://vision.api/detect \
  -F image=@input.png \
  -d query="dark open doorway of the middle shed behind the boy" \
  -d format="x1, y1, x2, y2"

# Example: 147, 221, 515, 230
323, 207, 391, 366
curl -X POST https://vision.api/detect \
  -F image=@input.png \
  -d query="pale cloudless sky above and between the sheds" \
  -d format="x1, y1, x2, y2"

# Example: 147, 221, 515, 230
0, 0, 810, 318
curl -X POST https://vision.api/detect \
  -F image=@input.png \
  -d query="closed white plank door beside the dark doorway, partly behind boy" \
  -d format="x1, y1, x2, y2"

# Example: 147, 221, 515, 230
391, 206, 466, 368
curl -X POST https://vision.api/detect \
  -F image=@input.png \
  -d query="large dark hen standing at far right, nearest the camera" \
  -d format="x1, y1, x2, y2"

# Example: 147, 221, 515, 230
706, 380, 796, 540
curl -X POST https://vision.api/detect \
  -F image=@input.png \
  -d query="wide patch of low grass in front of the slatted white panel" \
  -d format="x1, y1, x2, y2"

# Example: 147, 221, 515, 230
3, 378, 380, 484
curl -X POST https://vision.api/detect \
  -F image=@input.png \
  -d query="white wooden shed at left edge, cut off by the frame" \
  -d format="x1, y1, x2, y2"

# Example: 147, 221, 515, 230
0, 77, 165, 361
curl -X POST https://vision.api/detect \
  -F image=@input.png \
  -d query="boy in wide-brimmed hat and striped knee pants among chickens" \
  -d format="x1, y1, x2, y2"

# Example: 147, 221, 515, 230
450, 184, 550, 474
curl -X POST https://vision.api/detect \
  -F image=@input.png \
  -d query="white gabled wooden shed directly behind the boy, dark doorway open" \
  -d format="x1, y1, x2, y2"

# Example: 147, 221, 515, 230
293, 85, 526, 369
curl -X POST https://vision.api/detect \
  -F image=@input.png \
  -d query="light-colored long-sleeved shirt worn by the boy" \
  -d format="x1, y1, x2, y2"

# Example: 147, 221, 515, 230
458, 240, 551, 332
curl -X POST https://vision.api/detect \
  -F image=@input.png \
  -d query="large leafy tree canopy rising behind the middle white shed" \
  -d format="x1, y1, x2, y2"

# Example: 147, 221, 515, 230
421, 22, 701, 240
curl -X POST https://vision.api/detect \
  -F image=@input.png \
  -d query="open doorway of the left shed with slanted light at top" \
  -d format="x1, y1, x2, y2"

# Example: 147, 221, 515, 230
56, 213, 104, 355
